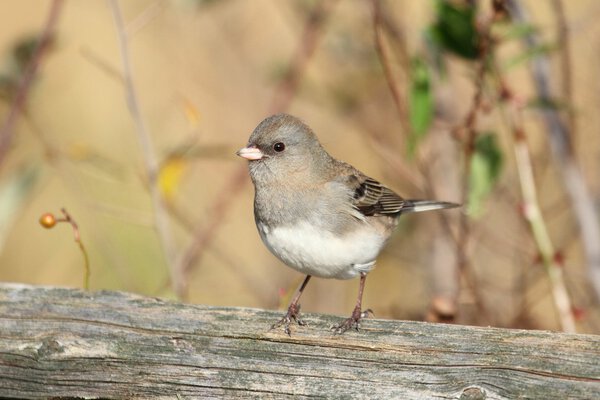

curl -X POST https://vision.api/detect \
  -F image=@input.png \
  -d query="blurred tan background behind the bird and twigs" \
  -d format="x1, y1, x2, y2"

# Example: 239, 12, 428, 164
0, 0, 600, 333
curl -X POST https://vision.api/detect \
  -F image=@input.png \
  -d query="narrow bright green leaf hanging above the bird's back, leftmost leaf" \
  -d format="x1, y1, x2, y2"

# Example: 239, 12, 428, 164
407, 57, 433, 157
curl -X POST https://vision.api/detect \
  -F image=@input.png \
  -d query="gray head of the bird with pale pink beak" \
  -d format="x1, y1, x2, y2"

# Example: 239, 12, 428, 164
237, 114, 331, 184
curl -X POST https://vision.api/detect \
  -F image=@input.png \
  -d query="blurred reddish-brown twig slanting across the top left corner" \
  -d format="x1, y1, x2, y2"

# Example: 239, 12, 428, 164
0, 0, 63, 165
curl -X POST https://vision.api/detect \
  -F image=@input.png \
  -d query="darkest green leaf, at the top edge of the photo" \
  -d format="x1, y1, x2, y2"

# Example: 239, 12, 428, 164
429, 0, 479, 60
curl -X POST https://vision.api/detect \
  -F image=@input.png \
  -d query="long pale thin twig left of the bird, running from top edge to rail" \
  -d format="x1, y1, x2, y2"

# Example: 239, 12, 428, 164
109, 0, 179, 296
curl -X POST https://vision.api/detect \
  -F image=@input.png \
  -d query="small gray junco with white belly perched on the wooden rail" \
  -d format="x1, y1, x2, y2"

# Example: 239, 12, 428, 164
237, 114, 458, 335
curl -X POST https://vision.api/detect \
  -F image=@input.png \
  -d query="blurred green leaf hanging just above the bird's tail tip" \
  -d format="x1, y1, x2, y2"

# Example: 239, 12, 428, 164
467, 132, 503, 217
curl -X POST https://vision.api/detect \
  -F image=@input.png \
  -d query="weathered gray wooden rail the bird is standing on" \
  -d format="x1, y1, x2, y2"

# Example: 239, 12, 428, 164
0, 284, 600, 400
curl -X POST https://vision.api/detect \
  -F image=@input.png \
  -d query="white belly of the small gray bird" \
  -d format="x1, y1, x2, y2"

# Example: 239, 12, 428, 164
258, 223, 385, 279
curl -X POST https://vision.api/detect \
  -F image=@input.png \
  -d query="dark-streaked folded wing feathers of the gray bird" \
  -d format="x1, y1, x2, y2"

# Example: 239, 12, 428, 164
349, 175, 406, 216
